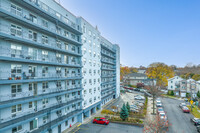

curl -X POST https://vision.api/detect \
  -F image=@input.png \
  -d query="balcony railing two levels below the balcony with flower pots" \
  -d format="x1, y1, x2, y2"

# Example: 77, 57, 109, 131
0, 96, 81, 124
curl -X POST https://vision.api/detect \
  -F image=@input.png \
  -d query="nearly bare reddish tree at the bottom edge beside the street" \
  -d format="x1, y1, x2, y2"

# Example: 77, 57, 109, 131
143, 115, 169, 133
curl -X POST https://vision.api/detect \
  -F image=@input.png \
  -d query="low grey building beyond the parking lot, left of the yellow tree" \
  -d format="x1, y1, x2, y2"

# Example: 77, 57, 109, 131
123, 73, 156, 85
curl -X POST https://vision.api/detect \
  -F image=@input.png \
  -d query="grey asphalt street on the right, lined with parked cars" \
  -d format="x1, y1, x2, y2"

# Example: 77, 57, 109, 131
162, 98, 197, 133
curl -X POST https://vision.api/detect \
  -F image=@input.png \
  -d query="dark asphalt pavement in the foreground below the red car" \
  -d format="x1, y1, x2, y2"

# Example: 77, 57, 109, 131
75, 123, 143, 133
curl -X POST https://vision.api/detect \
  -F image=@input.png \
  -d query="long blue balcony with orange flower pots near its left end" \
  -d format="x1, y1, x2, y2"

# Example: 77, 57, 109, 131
0, 71, 82, 85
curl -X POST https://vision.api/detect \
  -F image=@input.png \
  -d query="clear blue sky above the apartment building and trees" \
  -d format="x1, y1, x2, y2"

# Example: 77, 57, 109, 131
60, 0, 200, 67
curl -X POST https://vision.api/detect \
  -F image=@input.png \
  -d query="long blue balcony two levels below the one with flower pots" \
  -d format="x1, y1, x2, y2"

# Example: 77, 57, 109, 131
0, 97, 82, 132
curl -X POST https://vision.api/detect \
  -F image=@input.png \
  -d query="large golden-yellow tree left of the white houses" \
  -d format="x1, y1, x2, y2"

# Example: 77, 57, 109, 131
146, 62, 174, 87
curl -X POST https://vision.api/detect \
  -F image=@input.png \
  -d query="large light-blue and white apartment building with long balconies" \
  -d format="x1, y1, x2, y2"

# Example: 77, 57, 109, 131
0, 0, 120, 133
